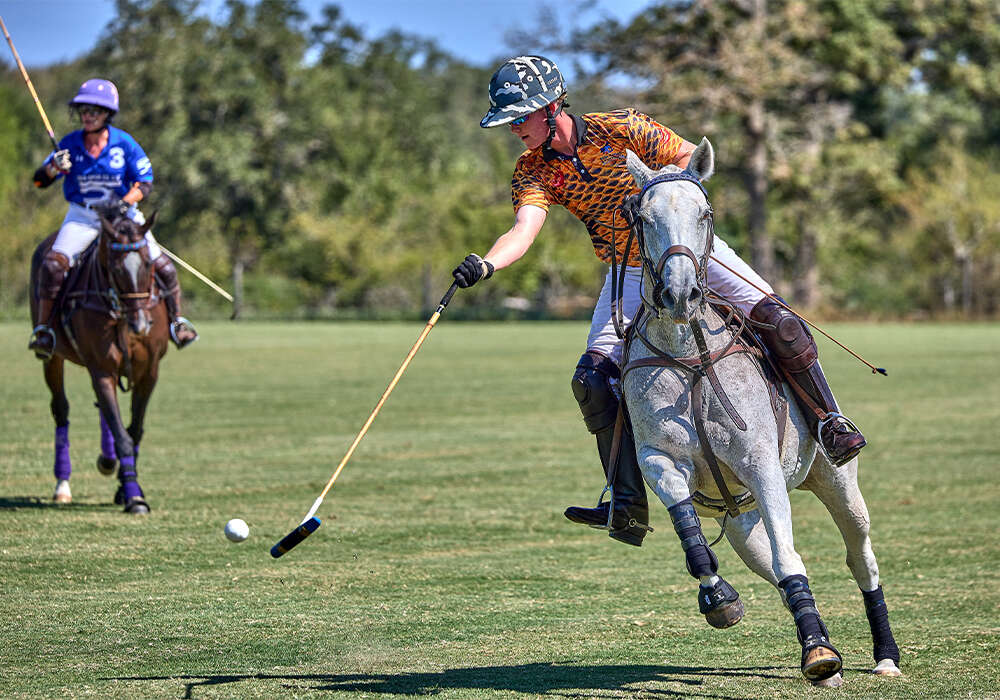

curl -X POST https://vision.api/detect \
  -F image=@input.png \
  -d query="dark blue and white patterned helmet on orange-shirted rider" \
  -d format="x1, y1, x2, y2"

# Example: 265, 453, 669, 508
479, 56, 566, 129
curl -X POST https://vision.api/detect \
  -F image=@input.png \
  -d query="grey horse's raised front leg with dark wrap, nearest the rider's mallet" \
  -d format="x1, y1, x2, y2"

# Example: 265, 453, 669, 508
638, 445, 743, 629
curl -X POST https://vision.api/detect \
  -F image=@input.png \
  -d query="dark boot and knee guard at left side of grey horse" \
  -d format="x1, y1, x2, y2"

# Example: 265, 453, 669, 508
565, 351, 653, 547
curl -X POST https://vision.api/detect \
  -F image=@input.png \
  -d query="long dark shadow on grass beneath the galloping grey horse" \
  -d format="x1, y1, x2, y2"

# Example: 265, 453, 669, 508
111, 663, 789, 698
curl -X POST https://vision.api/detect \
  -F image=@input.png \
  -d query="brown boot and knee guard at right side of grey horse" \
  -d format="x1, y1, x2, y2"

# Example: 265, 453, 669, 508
750, 297, 867, 467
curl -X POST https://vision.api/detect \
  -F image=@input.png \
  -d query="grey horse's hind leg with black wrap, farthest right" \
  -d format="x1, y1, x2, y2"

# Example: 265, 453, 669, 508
803, 457, 901, 676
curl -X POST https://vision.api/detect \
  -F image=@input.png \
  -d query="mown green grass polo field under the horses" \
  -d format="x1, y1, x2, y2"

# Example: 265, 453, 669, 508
0, 318, 1000, 698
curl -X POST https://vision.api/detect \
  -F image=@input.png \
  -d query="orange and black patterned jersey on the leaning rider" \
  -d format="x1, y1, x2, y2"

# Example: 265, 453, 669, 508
511, 109, 684, 265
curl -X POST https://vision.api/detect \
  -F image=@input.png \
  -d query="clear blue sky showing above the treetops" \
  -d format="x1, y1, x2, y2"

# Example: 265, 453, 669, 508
0, 0, 651, 68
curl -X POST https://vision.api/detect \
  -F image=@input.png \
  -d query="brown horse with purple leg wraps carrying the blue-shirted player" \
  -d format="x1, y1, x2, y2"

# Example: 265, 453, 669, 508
31, 214, 169, 514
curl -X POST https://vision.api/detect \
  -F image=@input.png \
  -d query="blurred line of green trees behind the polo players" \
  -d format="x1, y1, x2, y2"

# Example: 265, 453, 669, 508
0, 0, 1000, 317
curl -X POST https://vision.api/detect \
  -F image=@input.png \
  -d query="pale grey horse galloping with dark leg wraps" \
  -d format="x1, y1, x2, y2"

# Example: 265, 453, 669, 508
622, 139, 900, 685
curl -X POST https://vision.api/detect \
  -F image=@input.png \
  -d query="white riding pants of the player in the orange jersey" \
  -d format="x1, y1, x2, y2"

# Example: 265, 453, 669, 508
587, 236, 774, 365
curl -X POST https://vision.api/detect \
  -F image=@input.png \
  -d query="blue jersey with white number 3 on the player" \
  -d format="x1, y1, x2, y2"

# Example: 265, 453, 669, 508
46, 126, 153, 205
